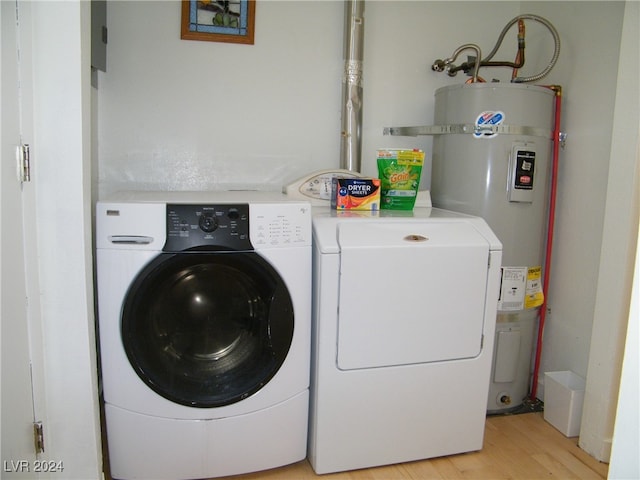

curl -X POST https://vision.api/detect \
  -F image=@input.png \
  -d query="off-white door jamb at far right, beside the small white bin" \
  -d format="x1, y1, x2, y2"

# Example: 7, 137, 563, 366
580, 2, 640, 460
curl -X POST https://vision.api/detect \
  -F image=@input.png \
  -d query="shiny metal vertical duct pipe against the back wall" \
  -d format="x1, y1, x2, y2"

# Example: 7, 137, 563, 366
340, 0, 364, 172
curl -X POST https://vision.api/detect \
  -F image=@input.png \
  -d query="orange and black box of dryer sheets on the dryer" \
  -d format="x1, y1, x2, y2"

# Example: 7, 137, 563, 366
331, 177, 380, 210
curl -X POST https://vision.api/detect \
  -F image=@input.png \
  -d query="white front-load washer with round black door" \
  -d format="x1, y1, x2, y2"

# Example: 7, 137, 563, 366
96, 192, 311, 480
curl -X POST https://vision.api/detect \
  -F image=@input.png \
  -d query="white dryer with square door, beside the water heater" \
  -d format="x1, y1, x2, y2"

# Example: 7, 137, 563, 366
308, 208, 502, 473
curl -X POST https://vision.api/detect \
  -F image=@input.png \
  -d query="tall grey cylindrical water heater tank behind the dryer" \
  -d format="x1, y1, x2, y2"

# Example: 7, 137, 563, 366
431, 83, 554, 413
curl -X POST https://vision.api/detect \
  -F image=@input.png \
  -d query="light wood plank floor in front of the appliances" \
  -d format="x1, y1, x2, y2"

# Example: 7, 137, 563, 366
218, 413, 608, 480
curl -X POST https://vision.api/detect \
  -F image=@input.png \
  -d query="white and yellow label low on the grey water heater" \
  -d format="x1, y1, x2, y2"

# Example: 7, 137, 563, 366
498, 267, 544, 312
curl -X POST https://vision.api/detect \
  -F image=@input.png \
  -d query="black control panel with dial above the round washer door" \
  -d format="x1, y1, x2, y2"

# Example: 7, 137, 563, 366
163, 204, 253, 252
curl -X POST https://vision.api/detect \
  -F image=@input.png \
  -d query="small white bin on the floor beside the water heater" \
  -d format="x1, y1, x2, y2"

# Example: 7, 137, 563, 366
544, 370, 585, 437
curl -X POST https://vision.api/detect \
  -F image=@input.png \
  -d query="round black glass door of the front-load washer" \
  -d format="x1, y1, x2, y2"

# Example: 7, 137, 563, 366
122, 252, 294, 408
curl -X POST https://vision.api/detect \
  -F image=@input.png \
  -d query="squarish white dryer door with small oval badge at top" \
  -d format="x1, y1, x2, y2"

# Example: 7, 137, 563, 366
337, 222, 489, 370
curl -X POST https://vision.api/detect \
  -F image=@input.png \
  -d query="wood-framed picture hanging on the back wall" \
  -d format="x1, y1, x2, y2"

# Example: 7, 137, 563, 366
180, 0, 256, 45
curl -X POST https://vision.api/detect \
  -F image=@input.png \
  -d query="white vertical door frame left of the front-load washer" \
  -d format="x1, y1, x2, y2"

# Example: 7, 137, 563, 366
28, 1, 102, 480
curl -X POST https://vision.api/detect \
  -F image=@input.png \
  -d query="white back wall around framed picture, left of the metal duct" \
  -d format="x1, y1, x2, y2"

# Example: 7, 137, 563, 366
99, 1, 343, 194
